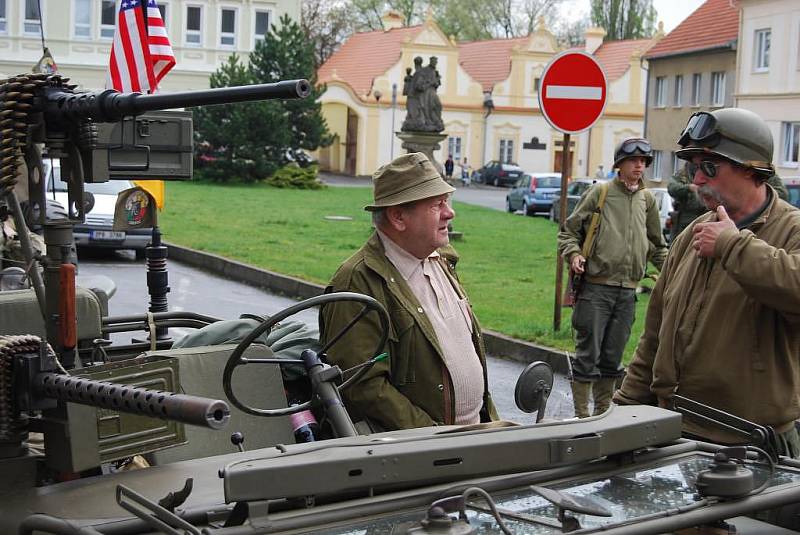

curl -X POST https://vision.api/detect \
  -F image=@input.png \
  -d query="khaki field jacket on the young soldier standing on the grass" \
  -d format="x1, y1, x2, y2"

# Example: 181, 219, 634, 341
558, 177, 667, 288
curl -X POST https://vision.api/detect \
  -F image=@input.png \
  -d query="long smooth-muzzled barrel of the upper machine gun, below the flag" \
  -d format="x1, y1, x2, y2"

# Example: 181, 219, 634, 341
45, 80, 311, 122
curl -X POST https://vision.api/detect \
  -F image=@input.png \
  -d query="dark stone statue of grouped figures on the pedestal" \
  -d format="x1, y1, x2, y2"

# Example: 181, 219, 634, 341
400, 56, 444, 133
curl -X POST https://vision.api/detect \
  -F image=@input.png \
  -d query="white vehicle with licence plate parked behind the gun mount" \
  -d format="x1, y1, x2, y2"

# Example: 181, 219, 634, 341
44, 158, 153, 258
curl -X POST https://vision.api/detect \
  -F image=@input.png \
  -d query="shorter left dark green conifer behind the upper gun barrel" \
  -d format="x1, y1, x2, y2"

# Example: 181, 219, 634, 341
194, 54, 291, 182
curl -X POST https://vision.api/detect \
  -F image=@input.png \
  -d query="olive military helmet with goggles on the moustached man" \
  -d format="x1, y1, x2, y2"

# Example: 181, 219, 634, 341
675, 108, 775, 176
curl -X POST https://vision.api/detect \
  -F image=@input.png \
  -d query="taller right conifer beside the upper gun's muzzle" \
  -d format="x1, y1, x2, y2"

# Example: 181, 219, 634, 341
250, 15, 331, 155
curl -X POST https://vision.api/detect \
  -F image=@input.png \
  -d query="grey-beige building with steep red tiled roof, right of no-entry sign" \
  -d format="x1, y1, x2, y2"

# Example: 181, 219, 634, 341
645, 0, 739, 185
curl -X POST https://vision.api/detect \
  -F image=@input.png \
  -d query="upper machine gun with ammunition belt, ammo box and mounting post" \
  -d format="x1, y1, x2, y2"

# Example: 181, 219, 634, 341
0, 74, 310, 360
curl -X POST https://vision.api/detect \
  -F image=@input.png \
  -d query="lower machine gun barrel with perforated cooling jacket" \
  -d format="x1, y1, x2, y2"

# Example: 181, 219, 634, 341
34, 373, 231, 429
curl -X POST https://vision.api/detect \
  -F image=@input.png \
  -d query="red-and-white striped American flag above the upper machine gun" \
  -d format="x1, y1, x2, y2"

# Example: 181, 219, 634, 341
107, 0, 175, 93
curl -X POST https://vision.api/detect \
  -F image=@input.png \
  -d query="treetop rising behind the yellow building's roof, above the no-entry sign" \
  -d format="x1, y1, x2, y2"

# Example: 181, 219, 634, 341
591, 0, 657, 41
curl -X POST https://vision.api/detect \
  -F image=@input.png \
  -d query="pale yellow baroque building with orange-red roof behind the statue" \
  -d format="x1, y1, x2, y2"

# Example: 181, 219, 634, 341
318, 13, 655, 176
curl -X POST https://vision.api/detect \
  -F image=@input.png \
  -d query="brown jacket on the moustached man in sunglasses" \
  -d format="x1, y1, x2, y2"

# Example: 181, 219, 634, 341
614, 188, 800, 443
